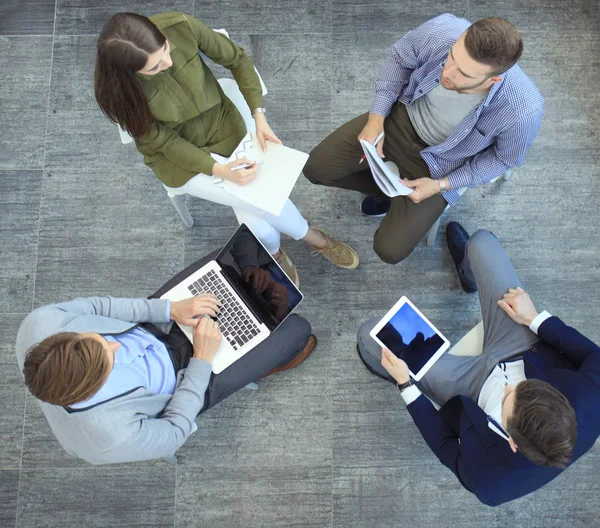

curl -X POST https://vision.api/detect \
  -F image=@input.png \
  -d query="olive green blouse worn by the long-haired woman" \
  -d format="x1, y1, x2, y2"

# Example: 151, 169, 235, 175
136, 12, 263, 187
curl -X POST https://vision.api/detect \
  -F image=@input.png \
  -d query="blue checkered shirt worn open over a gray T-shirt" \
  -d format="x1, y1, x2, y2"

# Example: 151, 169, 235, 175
371, 14, 544, 205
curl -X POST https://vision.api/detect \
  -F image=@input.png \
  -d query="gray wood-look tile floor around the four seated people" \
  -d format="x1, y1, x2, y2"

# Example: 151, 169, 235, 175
0, 0, 600, 528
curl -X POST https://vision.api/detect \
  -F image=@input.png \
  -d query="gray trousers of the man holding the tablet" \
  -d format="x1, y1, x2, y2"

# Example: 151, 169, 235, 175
358, 230, 539, 405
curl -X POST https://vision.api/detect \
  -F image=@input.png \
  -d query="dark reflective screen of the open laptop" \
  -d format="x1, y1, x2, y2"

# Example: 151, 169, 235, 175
216, 224, 302, 331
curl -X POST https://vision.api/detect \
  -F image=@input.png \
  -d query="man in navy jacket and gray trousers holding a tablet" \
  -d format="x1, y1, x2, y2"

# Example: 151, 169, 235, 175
358, 222, 600, 506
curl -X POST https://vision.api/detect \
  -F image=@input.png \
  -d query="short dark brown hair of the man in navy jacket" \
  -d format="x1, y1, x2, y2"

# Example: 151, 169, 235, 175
506, 379, 577, 469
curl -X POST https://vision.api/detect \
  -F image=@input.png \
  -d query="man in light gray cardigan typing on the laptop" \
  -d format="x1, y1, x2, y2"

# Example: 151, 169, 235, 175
16, 294, 316, 464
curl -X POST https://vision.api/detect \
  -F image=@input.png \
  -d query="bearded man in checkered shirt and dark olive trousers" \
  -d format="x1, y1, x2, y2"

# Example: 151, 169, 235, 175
304, 14, 544, 264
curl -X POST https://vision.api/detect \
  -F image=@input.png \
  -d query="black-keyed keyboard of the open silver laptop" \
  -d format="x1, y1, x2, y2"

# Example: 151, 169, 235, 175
188, 270, 260, 350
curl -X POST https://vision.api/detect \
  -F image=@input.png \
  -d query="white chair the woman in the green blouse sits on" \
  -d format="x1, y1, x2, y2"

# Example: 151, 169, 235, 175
117, 29, 268, 228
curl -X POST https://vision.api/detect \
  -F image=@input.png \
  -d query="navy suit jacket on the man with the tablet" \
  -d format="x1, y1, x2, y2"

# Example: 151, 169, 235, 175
408, 317, 600, 506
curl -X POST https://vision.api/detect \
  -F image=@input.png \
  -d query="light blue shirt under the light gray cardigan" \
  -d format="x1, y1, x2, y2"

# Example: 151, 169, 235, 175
70, 327, 176, 409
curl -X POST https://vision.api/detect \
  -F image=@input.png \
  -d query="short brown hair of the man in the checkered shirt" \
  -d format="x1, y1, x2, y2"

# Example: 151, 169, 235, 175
465, 17, 523, 77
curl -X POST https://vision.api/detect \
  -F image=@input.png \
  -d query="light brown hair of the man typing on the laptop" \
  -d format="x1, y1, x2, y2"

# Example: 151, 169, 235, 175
23, 332, 112, 405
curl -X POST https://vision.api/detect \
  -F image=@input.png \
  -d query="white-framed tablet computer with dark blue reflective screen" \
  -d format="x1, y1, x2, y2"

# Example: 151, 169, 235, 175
371, 297, 450, 381
